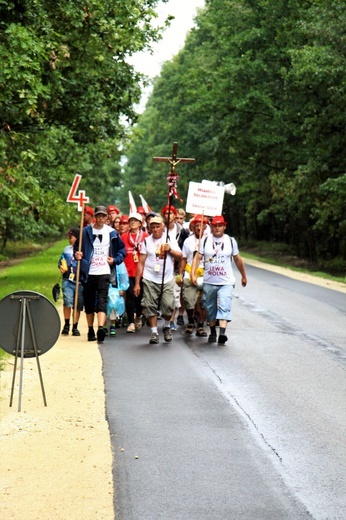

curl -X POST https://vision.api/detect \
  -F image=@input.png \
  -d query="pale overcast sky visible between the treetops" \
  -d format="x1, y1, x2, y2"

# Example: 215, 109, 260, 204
131, 0, 204, 111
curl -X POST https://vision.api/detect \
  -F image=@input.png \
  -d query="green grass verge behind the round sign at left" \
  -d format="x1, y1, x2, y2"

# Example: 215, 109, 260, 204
0, 239, 68, 366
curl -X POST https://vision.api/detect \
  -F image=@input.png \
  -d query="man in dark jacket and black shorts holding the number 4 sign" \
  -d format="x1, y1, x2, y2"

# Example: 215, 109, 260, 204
74, 206, 126, 343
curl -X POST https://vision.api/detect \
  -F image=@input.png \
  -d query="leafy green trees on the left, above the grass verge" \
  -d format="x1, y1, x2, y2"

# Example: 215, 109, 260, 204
0, 0, 168, 245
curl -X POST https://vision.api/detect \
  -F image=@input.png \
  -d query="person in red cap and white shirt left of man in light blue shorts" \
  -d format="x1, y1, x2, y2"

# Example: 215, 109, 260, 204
177, 215, 208, 337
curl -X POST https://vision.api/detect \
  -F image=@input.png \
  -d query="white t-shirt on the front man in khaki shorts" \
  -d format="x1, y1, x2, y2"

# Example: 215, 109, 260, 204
141, 233, 180, 283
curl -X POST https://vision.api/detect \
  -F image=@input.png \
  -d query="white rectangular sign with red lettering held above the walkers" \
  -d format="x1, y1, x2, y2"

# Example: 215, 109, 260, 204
186, 182, 225, 217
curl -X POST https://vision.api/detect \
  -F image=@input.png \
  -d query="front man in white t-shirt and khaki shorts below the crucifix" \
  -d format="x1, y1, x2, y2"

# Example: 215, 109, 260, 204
134, 217, 182, 344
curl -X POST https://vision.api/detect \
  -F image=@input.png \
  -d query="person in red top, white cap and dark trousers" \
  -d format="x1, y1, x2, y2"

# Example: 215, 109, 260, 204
121, 212, 148, 332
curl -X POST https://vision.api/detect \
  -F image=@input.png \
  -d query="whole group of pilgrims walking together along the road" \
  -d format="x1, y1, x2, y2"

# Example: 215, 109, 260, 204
58, 204, 247, 345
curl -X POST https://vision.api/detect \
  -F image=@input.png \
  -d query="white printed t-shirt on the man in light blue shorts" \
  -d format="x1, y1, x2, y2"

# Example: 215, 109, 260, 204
199, 234, 239, 285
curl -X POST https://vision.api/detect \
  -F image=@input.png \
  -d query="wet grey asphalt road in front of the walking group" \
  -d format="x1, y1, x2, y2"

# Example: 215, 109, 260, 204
100, 266, 346, 520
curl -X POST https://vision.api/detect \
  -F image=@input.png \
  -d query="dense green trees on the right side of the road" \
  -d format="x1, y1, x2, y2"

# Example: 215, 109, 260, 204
122, 0, 346, 261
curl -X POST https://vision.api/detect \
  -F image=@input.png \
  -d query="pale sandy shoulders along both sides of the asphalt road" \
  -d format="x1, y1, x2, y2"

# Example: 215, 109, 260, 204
0, 260, 346, 520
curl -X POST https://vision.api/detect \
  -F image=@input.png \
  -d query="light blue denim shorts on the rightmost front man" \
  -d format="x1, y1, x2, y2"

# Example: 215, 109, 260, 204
201, 283, 233, 322
